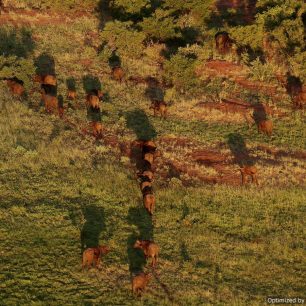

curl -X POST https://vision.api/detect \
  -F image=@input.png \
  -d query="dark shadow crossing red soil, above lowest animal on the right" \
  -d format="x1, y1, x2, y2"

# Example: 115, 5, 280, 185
227, 133, 254, 167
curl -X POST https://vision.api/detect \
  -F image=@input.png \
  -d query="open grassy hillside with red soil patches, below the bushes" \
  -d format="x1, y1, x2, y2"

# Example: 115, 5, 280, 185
0, 0, 306, 305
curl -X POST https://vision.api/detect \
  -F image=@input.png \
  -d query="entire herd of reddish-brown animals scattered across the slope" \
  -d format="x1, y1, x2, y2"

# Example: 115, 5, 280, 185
1, 32, 303, 296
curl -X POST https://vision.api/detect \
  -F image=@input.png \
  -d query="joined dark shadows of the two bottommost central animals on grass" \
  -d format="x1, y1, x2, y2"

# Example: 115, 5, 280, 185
127, 207, 153, 274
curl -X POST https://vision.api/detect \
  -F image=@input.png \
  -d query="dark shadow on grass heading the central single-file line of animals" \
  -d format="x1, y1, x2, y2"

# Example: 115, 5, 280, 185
125, 109, 157, 140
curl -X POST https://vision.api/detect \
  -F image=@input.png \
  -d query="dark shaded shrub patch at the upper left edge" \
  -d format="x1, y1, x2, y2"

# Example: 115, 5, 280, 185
0, 28, 35, 58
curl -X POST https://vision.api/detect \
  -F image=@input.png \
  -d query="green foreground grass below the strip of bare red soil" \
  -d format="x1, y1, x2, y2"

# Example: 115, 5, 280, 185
0, 96, 306, 305
